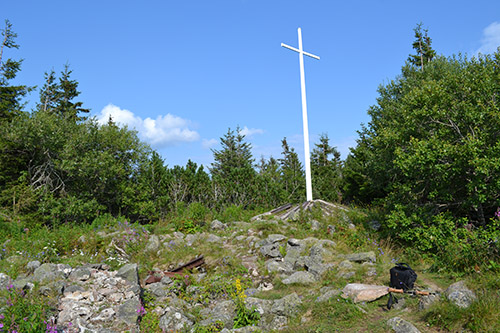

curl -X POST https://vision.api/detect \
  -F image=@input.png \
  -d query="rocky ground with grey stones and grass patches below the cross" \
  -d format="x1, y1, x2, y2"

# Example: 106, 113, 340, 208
0, 209, 475, 332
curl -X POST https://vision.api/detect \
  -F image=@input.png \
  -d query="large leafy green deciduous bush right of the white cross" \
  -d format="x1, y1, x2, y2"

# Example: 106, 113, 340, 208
344, 36, 500, 268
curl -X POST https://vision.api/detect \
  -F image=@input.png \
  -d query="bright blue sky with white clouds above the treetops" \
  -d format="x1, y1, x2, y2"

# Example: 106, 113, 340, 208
0, 0, 500, 166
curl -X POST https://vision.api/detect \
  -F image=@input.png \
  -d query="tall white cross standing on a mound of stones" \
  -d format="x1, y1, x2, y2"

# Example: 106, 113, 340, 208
281, 28, 319, 201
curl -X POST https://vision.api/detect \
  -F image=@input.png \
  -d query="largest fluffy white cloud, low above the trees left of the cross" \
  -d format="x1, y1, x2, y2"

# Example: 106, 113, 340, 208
97, 104, 200, 147
